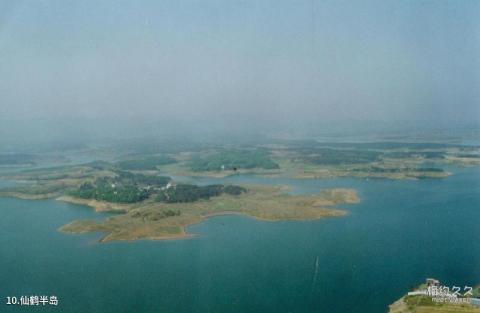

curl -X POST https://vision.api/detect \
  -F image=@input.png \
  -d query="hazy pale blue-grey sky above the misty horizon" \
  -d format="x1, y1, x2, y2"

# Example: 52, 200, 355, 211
0, 0, 480, 138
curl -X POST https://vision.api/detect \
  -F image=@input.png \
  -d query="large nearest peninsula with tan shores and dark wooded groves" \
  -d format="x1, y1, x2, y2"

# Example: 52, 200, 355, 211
0, 162, 359, 242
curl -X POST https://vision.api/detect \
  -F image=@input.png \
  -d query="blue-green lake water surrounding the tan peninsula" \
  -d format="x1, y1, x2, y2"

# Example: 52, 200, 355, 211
0, 168, 480, 313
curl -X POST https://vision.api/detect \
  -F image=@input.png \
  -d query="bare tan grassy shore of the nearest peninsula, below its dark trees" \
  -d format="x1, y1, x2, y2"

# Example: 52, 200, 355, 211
56, 186, 360, 242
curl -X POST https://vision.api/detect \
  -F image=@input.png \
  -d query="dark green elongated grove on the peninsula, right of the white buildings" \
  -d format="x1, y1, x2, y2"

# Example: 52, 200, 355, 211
156, 184, 247, 203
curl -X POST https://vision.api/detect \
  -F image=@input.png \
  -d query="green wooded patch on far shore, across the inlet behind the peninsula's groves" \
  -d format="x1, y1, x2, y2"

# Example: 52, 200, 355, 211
189, 149, 279, 172
